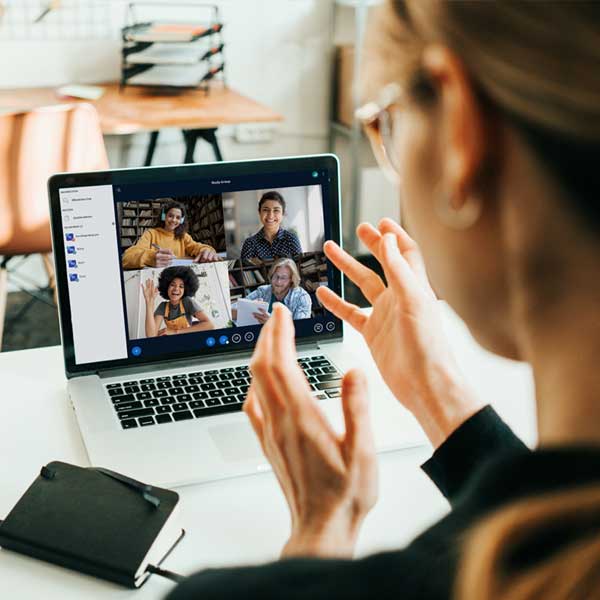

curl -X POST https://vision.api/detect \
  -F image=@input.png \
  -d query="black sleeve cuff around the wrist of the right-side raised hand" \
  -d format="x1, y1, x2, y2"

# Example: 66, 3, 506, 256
421, 405, 526, 506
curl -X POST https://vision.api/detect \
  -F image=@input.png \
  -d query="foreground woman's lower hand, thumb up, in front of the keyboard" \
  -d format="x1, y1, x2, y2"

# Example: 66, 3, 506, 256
244, 304, 377, 556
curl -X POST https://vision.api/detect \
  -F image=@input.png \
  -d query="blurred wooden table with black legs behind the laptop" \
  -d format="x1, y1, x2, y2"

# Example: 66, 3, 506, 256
0, 83, 283, 165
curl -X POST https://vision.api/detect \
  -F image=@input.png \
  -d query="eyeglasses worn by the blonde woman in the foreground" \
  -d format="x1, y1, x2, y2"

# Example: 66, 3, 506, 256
355, 83, 405, 183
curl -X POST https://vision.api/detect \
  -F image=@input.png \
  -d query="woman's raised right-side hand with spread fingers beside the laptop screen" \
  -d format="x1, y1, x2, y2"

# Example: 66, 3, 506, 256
317, 219, 484, 447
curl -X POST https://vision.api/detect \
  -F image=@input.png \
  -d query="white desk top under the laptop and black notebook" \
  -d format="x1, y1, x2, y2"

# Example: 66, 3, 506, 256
0, 310, 536, 600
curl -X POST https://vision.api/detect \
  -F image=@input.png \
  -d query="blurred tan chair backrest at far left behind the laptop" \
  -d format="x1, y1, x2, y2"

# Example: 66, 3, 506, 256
0, 103, 108, 256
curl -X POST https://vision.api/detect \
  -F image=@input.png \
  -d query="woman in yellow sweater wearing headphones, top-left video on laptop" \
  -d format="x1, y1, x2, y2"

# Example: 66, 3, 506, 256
122, 200, 219, 269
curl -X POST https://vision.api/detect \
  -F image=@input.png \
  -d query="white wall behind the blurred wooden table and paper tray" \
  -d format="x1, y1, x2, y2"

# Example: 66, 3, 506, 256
0, 0, 331, 290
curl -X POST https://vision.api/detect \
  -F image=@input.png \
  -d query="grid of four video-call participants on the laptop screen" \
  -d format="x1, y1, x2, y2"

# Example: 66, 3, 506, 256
117, 185, 328, 340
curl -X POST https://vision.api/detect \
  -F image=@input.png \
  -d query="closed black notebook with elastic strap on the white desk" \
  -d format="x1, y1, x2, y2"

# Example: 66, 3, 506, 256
0, 462, 184, 587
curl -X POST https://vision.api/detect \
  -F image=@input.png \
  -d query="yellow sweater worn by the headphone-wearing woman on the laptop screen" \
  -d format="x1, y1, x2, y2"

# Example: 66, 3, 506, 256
122, 227, 214, 269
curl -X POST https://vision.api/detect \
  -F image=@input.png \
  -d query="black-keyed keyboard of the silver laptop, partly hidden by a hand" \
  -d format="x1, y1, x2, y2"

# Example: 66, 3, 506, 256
105, 356, 342, 429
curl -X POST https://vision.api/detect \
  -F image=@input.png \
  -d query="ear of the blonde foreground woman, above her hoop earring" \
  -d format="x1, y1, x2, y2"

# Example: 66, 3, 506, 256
423, 45, 490, 210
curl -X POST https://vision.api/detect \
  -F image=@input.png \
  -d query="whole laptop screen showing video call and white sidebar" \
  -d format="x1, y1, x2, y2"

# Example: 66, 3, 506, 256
55, 157, 341, 371
